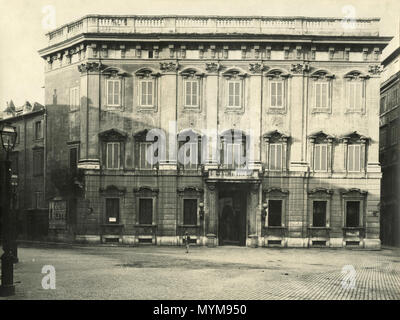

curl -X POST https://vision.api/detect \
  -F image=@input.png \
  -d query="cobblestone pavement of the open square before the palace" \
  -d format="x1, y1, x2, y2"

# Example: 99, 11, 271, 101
1, 246, 400, 300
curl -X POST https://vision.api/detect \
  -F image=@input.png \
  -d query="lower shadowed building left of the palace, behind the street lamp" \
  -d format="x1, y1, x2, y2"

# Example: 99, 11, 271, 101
0, 102, 48, 239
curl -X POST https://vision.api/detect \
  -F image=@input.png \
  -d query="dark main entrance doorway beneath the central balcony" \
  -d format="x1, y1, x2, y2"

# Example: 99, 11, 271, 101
218, 184, 247, 246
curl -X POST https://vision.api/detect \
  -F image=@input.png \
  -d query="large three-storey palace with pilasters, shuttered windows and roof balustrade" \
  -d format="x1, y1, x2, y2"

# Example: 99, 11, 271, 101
36, 15, 390, 248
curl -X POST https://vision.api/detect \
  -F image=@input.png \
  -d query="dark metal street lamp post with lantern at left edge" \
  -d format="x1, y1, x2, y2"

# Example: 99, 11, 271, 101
0, 123, 17, 297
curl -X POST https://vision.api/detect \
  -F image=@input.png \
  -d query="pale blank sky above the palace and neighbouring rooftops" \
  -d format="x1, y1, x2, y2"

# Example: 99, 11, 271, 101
0, 0, 400, 110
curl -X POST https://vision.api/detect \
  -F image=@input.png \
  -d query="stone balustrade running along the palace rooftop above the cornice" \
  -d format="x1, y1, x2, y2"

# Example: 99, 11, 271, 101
47, 15, 379, 46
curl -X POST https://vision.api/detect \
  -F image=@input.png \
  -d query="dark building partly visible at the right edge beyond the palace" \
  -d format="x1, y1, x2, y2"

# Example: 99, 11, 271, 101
379, 33, 400, 246
